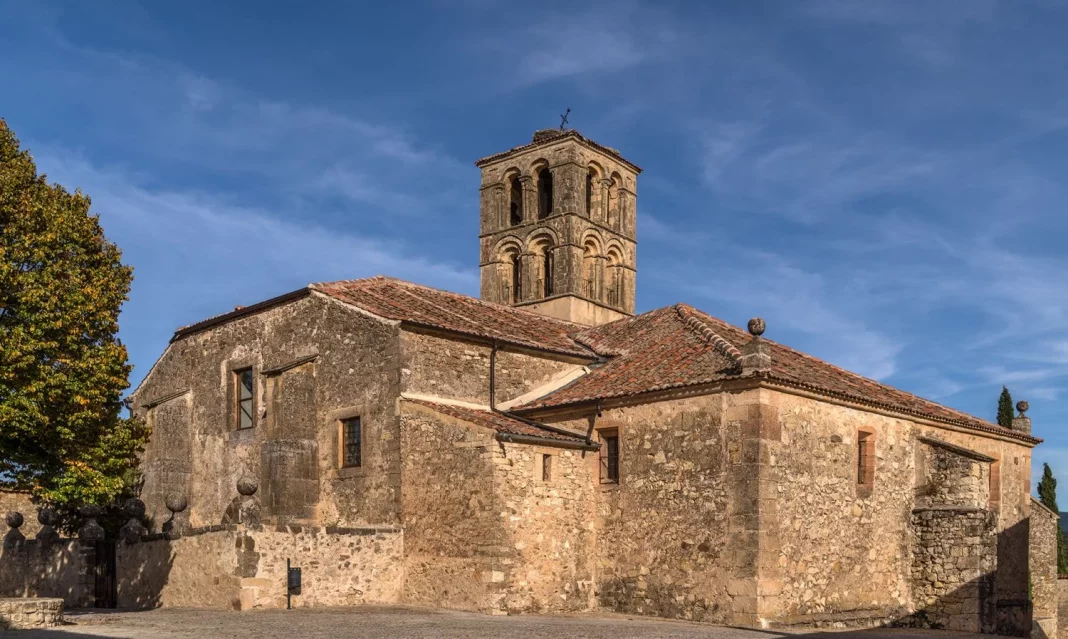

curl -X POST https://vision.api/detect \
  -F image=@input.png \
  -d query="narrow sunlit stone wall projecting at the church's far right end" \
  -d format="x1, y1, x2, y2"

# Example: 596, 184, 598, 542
1028, 499, 1059, 639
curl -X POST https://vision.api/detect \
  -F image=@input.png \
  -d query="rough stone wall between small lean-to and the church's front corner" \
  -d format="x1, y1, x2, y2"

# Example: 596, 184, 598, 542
562, 394, 743, 623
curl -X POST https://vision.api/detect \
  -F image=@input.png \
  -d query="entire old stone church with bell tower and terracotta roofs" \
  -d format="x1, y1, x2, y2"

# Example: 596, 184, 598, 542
120, 130, 1056, 635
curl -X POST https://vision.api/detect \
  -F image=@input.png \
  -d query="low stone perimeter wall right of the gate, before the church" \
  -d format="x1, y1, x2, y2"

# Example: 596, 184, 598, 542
116, 526, 404, 610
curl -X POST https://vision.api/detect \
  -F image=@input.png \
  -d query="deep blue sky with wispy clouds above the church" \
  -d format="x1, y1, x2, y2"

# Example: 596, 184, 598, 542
0, 0, 1068, 491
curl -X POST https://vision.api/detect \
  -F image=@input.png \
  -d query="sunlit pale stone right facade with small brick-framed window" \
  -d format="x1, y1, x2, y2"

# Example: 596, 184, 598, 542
767, 393, 1031, 627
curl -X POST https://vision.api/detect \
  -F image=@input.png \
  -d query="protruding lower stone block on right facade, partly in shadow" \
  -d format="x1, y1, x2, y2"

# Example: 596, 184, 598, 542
912, 506, 998, 633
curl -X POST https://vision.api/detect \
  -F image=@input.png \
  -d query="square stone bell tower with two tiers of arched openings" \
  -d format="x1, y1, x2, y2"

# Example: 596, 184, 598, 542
475, 129, 642, 326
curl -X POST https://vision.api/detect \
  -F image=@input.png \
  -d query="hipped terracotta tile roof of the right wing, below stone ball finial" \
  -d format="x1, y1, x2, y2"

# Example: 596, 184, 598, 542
515, 305, 1041, 442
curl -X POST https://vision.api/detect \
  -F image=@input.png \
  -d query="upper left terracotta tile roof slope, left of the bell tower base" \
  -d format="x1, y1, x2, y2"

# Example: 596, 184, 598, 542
310, 276, 595, 359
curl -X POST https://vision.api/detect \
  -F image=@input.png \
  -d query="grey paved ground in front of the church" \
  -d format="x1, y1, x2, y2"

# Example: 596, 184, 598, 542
12, 606, 991, 639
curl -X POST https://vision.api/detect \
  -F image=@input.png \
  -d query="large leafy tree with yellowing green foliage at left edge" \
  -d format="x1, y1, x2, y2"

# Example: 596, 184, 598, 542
0, 120, 147, 512
